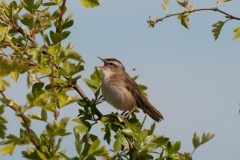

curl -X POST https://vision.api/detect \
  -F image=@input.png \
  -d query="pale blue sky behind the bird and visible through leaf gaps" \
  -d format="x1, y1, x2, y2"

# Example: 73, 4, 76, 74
1, 0, 240, 160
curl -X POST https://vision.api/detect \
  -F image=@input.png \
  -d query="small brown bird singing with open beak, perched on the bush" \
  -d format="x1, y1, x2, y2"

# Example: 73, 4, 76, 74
97, 57, 164, 122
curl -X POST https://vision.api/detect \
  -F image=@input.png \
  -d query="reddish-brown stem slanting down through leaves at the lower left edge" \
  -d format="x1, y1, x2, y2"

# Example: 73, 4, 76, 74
0, 91, 40, 150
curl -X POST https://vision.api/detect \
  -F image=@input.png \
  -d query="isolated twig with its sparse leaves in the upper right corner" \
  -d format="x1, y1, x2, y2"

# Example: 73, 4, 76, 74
148, 0, 240, 40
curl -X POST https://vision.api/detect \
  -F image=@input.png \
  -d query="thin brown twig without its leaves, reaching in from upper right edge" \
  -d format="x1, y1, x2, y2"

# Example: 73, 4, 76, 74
147, 8, 240, 24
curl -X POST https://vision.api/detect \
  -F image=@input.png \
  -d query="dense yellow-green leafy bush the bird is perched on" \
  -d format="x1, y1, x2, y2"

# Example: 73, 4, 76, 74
0, 0, 215, 160
